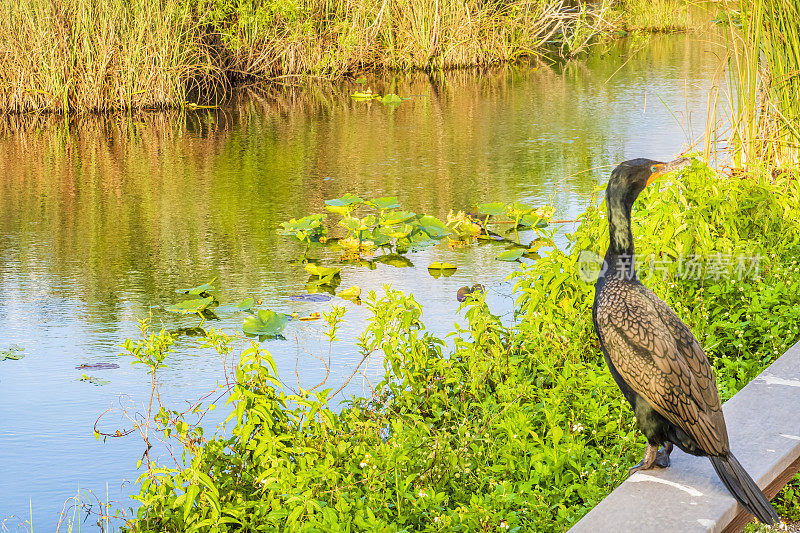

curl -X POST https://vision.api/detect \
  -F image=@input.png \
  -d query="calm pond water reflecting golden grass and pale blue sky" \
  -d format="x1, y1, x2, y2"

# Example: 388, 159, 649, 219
0, 36, 720, 531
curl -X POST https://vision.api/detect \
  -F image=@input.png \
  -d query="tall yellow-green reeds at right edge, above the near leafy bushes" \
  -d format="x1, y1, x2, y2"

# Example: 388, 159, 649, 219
726, 0, 800, 171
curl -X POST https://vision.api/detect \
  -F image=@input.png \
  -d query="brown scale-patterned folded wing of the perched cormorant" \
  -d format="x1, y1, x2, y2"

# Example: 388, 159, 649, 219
598, 291, 728, 455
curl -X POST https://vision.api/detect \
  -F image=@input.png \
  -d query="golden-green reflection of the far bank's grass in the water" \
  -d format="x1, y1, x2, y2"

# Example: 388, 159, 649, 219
0, 37, 720, 324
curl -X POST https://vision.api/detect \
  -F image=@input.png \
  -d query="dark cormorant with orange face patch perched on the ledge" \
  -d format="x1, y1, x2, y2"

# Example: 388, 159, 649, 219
592, 159, 779, 524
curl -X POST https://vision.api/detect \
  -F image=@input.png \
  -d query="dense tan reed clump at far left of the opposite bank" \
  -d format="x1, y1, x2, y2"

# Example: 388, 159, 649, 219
0, 0, 224, 113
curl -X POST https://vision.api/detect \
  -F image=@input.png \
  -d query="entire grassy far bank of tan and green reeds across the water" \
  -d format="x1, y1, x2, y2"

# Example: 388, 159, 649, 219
0, 0, 700, 113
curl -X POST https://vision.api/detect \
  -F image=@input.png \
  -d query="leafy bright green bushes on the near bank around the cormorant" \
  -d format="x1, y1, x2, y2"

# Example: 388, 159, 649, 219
117, 163, 800, 531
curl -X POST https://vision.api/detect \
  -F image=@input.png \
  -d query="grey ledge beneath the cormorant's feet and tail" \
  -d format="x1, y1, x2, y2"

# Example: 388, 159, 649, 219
570, 342, 800, 533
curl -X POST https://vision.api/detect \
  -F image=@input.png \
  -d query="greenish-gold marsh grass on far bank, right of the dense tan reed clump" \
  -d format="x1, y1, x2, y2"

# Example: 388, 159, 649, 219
197, 0, 608, 78
